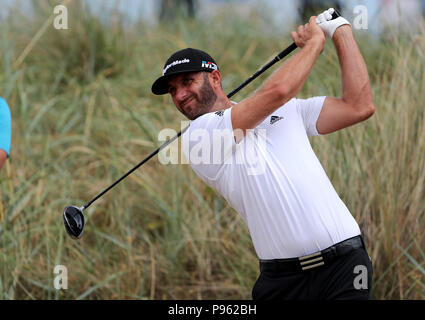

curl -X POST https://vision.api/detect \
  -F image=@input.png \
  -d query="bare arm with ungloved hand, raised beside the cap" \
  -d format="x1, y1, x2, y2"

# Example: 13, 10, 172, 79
231, 17, 325, 141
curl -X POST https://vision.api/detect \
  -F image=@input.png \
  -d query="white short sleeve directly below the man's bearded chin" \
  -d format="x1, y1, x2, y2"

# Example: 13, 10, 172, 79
182, 108, 236, 180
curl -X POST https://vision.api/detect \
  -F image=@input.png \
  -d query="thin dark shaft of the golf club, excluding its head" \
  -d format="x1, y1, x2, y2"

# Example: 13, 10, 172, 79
82, 43, 297, 210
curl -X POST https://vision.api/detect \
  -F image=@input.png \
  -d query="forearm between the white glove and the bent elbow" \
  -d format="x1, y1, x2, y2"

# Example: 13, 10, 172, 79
332, 25, 373, 111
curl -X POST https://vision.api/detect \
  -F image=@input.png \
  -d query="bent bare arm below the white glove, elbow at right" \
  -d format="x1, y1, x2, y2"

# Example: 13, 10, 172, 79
316, 25, 375, 134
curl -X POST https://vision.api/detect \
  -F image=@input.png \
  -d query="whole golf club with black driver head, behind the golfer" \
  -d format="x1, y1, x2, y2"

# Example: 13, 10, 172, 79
63, 10, 340, 239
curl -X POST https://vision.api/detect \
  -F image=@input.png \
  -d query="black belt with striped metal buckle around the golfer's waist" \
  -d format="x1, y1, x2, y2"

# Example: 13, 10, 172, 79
260, 235, 365, 272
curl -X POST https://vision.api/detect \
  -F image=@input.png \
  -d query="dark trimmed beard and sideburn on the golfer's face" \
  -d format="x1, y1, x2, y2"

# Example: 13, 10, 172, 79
181, 72, 217, 120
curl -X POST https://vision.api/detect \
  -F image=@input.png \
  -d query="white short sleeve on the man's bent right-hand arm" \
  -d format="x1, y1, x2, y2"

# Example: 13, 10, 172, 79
296, 96, 326, 136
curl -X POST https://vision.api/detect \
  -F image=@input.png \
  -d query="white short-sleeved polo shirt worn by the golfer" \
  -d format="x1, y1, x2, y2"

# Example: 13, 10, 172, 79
182, 97, 360, 259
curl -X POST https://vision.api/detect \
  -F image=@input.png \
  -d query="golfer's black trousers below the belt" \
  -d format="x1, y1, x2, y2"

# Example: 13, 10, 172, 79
252, 248, 373, 301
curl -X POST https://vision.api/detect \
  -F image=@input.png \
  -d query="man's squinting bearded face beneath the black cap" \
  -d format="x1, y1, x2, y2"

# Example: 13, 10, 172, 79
168, 72, 217, 120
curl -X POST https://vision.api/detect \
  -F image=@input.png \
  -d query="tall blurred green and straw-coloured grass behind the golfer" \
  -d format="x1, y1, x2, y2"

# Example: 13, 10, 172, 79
0, 0, 425, 299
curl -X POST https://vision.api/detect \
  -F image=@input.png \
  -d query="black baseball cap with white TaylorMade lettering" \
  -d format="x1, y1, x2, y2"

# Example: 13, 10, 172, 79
152, 48, 218, 95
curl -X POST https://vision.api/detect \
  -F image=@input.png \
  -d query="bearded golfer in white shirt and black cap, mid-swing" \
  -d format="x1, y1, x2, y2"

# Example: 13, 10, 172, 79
152, 8, 375, 300
